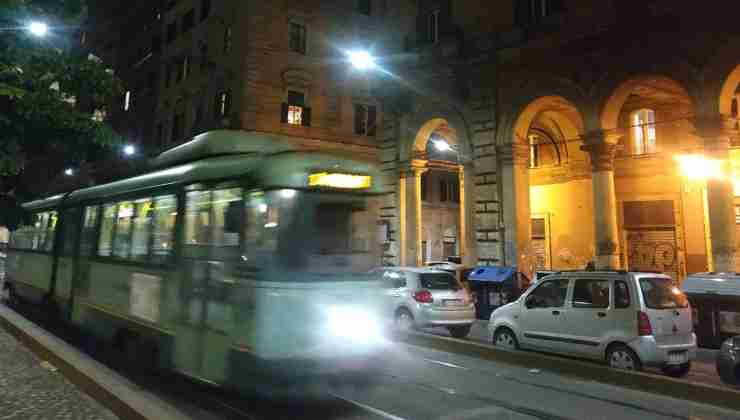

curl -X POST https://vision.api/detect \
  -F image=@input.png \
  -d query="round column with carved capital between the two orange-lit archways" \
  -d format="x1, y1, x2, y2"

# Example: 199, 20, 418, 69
581, 131, 622, 269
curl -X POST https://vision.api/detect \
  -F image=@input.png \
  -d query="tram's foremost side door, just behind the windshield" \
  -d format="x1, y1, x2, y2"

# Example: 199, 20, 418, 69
174, 188, 243, 383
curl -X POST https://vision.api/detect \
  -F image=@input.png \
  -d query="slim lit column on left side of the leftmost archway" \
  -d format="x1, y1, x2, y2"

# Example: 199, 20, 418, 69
398, 160, 426, 266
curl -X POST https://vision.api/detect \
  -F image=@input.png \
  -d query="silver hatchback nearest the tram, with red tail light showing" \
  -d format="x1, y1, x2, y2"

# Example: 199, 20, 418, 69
376, 267, 475, 338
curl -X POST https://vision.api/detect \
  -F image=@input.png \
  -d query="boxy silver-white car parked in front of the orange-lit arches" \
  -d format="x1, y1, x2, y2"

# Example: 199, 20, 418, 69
489, 271, 696, 376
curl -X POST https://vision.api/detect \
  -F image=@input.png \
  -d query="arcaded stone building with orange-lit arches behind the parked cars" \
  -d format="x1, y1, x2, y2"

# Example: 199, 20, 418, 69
381, 0, 740, 278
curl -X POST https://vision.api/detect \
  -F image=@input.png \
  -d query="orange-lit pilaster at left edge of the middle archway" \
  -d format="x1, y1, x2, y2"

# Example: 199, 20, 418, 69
496, 143, 532, 270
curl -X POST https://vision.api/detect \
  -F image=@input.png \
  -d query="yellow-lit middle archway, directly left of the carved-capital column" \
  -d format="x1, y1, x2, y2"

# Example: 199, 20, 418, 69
503, 96, 593, 272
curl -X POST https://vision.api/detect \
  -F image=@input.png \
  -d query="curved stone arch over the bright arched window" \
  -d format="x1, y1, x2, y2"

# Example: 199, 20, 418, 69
600, 73, 698, 131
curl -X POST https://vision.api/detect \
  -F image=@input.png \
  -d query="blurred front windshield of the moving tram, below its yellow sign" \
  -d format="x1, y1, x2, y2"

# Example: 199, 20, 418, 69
244, 190, 380, 275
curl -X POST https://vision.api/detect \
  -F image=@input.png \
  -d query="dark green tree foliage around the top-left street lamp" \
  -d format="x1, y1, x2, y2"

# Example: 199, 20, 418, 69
0, 0, 122, 228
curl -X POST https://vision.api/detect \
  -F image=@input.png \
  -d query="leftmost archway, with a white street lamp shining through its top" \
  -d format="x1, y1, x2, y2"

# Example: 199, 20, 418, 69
399, 118, 477, 266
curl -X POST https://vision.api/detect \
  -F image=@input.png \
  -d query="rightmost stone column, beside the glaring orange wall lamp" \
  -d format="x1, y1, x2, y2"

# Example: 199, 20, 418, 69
696, 116, 737, 272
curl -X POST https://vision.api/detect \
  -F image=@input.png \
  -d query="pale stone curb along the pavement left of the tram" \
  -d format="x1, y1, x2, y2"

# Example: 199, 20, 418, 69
0, 304, 189, 420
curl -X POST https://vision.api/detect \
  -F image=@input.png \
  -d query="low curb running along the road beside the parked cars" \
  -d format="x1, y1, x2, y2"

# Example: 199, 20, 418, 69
397, 332, 740, 411
